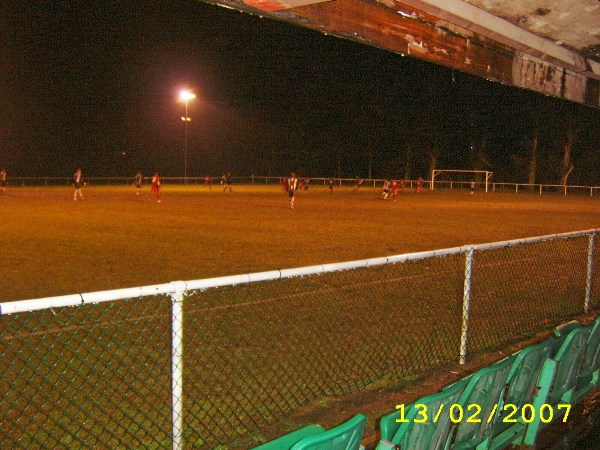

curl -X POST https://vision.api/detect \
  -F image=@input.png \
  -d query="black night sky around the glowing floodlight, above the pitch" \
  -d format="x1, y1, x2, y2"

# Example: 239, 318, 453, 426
0, 0, 600, 185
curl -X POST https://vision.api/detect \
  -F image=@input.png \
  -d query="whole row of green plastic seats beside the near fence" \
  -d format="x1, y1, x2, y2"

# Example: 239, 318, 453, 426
254, 316, 600, 450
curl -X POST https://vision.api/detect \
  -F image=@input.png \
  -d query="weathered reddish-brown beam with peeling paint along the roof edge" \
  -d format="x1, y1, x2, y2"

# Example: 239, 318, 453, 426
203, 0, 600, 107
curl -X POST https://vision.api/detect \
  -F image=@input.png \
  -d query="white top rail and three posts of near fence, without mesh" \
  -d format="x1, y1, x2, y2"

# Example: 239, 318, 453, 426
0, 229, 600, 450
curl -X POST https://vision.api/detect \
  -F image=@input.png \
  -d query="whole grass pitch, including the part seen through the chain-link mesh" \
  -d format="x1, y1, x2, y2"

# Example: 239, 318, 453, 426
0, 186, 600, 449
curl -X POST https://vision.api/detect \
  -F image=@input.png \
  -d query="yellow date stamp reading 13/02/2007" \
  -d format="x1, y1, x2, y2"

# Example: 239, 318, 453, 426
396, 403, 571, 424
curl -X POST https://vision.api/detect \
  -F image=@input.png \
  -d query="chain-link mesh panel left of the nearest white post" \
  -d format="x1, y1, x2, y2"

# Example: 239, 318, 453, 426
0, 296, 171, 449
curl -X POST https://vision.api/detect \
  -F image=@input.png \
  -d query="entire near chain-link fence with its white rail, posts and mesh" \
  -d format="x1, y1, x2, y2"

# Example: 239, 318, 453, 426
0, 232, 600, 449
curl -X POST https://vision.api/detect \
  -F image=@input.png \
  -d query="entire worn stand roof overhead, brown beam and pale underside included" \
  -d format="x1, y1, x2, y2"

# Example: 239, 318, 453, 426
198, 0, 600, 107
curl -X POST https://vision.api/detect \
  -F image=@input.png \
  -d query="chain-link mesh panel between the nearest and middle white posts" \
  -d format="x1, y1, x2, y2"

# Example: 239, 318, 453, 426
184, 255, 463, 447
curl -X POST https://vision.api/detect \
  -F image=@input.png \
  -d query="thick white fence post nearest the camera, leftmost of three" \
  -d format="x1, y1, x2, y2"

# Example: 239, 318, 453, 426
171, 281, 186, 450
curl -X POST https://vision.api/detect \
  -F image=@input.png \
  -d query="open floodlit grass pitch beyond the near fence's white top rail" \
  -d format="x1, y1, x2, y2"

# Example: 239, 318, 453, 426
0, 185, 600, 301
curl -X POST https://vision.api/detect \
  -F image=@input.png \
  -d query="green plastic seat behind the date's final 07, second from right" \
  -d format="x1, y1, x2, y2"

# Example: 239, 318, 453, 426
523, 327, 591, 446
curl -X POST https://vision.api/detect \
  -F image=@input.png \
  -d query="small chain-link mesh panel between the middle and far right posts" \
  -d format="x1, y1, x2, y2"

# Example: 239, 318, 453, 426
468, 236, 589, 353
